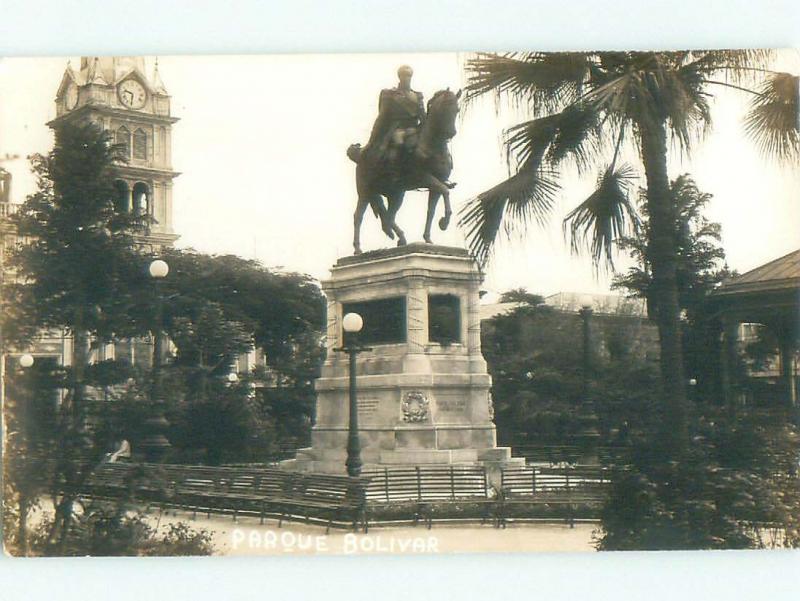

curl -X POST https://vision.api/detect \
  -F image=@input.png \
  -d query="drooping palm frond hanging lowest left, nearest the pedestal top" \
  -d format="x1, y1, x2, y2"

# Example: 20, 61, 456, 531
458, 162, 561, 265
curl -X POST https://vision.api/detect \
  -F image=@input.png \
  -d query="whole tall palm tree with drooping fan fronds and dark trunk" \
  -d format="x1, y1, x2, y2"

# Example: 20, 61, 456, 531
459, 50, 800, 449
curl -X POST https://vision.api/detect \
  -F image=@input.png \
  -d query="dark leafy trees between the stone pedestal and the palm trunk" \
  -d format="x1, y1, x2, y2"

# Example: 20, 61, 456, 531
481, 289, 655, 446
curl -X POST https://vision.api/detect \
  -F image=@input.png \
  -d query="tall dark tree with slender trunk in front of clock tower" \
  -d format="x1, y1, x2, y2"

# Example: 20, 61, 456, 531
11, 122, 146, 543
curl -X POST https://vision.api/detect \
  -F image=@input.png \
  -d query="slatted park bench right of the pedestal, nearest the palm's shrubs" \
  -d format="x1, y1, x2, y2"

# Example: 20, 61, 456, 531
496, 465, 608, 527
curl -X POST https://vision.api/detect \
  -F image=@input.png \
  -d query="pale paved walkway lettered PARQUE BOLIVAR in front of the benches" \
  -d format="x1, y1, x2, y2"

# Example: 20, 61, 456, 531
153, 512, 597, 555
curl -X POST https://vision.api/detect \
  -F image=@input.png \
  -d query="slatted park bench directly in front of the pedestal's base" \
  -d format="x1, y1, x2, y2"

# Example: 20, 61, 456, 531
366, 465, 494, 528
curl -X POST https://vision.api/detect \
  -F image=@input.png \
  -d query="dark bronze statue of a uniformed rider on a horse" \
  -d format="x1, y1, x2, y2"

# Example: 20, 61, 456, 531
347, 65, 461, 254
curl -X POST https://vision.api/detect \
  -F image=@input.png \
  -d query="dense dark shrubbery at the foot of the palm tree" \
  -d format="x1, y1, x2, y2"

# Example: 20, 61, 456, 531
595, 405, 800, 550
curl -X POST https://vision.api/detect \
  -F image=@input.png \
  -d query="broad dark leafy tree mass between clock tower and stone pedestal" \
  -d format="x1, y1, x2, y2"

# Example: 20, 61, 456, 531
116, 249, 325, 462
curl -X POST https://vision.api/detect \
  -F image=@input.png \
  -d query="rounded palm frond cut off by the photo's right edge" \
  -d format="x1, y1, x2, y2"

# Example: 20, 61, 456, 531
745, 73, 800, 162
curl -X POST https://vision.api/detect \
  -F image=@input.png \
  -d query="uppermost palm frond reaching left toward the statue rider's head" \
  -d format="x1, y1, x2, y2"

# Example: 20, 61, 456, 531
465, 52, 591, 116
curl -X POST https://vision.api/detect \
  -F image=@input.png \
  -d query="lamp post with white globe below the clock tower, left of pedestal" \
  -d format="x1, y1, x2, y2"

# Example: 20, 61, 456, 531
141, 259, 170, 462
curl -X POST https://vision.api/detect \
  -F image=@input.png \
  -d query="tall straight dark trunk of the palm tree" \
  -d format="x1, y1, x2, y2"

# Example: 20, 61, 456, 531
640, 123, 688, 456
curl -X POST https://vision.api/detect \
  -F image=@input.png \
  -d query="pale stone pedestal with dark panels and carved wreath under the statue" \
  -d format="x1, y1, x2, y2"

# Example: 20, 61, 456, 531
284, 244, 523, 473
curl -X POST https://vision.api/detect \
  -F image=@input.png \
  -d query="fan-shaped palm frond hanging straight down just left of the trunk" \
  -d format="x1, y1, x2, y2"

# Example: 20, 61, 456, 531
563, 164, 638, 267
